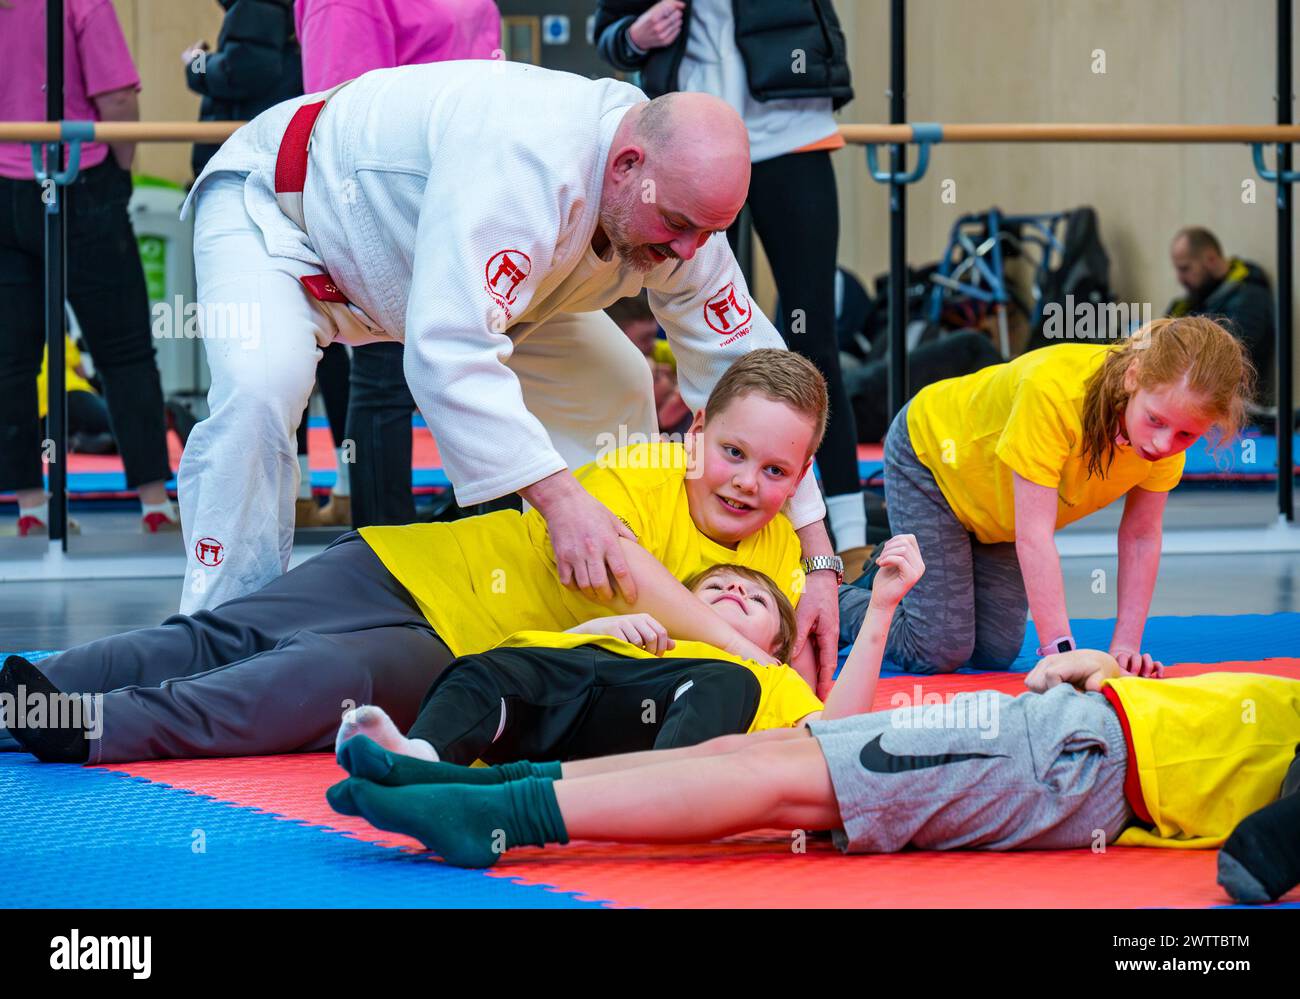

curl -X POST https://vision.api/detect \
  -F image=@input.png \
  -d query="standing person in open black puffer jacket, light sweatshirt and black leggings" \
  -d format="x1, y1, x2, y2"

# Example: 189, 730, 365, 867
595, 0, 868, 580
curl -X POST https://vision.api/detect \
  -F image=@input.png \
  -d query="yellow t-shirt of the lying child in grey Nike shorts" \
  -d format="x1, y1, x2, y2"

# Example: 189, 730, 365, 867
1105, 673, 1300, 849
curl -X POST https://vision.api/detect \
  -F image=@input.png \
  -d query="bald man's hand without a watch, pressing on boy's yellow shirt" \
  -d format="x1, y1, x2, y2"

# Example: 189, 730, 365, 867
519, 470, 637, 604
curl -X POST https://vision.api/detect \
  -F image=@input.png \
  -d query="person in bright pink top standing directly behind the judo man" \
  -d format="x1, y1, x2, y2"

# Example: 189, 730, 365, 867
294, 0, 502, 527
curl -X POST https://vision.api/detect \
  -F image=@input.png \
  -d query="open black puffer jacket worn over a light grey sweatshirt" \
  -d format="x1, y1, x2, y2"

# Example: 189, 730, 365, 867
595, 0, 853, 109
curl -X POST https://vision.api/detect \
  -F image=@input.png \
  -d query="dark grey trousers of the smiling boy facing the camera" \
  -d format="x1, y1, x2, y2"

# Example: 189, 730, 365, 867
0, 531, 455, 764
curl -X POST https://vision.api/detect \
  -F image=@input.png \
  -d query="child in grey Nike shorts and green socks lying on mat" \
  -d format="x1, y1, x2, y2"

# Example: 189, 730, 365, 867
328, 613, 1300, 901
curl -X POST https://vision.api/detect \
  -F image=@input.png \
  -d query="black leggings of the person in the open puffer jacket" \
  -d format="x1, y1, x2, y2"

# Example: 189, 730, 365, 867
727, 150, 862, 496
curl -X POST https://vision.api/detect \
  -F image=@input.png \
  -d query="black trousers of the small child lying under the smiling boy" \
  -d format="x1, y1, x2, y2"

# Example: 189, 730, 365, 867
407, 645, 759, 765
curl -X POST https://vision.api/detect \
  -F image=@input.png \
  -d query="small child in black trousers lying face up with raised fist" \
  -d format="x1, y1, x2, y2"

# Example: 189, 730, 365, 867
337, 536, 924, 777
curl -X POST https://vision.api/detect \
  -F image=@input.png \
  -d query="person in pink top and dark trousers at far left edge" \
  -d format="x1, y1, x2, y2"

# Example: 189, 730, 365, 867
0, 0, 179, 536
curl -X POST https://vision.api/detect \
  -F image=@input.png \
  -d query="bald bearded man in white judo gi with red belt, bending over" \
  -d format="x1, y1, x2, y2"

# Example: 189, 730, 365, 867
179, 61, 839, 679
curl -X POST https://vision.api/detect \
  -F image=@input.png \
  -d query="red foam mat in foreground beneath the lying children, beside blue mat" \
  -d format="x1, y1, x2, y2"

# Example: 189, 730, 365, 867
91, 658, 1300, 908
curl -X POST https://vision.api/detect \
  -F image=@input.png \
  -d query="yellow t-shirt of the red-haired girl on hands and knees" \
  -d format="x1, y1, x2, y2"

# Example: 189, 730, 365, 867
907, 343, 1184, 544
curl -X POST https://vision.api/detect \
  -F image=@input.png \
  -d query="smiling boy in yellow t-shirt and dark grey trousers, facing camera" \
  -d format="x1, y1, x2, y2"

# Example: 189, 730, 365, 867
0, 350, 827, 764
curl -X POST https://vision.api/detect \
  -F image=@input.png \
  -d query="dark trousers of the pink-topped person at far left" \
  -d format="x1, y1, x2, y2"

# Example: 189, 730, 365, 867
0, 155, 172, 492
